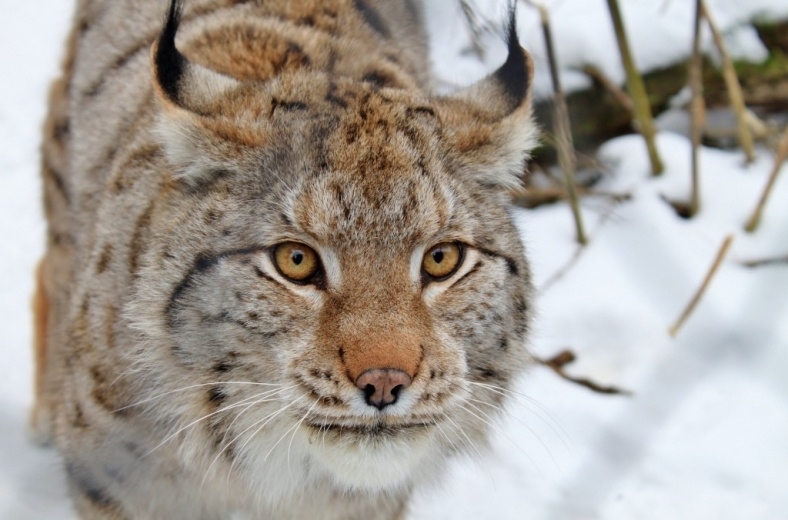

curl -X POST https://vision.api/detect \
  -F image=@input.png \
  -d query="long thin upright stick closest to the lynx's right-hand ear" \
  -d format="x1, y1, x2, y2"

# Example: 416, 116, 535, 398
533, 4, 588, 245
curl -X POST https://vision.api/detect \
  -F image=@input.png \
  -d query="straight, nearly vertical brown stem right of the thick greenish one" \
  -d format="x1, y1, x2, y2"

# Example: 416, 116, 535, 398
687, 0, 706, 217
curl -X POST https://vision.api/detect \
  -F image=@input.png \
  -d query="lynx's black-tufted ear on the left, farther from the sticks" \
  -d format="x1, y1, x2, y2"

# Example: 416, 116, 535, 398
151, 0, 246, 183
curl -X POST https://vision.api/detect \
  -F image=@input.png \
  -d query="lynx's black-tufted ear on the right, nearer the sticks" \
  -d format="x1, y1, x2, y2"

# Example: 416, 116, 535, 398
437, 7, 539, 188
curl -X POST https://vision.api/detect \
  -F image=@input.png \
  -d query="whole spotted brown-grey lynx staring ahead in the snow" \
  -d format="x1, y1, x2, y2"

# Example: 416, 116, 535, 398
31, 0, 535, 520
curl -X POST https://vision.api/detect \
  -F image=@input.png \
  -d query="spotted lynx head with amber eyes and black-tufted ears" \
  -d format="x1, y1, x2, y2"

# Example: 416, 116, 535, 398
132, 2, 535, 496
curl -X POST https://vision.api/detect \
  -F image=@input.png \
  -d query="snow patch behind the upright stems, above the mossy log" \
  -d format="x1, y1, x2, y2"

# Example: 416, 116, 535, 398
426, 0, 788, 98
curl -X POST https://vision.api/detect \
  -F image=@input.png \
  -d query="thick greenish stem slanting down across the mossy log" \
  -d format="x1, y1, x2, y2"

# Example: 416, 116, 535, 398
607, 0, 664, 175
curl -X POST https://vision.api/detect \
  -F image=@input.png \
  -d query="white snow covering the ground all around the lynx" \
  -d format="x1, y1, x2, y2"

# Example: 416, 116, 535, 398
0, 0, 788, 520
